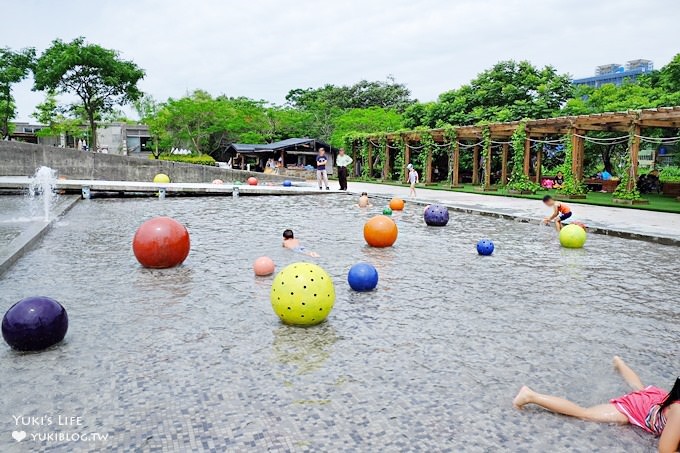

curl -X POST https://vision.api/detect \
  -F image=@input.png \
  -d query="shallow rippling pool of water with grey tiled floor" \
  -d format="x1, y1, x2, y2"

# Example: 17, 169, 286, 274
0, 195, 680, 452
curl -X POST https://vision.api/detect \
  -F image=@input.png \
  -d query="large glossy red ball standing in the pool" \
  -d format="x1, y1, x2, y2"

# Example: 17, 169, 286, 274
132, 217, 191, 269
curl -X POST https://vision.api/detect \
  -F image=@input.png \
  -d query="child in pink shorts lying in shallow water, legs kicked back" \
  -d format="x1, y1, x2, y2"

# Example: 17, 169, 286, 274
512, 356, 680, 453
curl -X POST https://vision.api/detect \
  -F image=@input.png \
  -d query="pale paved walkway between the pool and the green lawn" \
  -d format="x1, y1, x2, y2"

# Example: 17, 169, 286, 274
349, 182, 680, 245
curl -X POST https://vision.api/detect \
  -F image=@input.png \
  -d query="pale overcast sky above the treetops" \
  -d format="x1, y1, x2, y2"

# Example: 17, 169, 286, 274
0, 0, 680, 121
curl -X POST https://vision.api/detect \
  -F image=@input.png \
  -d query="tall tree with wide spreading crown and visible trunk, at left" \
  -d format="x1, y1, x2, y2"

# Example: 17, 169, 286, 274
34, 37, 144, 149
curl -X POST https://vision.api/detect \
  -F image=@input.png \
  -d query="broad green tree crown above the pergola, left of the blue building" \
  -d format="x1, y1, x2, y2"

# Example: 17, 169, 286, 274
406, 60, 573, 127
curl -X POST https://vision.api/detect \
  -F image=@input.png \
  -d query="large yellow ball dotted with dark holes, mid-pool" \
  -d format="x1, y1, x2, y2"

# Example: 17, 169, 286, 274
270, 262, 335, 326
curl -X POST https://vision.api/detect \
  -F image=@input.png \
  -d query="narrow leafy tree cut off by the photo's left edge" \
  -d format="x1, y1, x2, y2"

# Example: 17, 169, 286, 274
0, 47, 35, 139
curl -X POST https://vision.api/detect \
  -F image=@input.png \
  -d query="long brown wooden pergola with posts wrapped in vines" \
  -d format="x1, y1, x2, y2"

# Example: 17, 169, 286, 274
352, 107, 680, 190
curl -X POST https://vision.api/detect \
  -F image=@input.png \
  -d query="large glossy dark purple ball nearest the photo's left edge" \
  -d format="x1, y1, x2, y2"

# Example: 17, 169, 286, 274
2, 296, 68, 351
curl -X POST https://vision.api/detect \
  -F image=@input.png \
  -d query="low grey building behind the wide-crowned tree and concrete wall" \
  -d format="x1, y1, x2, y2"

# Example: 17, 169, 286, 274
10, 122, 151, 155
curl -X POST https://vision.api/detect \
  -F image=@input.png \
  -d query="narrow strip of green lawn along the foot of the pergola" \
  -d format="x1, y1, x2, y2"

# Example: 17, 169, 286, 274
350, 180, 680, 214
